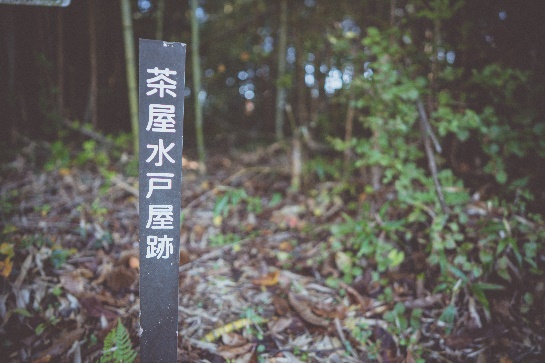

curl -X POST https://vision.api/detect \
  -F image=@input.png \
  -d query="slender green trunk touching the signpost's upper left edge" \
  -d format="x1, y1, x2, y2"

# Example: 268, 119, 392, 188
121, 0, 138, 155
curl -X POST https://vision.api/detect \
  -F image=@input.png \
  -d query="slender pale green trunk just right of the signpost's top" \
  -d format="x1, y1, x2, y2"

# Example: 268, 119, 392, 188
191, 0, 206, 174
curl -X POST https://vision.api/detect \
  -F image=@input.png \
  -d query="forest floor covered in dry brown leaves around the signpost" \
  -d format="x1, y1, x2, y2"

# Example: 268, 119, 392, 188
0, 143, 545, 363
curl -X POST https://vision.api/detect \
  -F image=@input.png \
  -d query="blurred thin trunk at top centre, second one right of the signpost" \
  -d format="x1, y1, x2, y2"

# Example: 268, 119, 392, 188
274, 0, 288, 140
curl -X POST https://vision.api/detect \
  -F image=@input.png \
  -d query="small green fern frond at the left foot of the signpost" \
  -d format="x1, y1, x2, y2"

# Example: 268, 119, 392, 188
100, 318, 136, 363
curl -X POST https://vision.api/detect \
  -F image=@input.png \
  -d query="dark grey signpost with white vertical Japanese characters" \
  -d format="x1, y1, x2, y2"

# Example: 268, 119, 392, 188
139, 39, 186, 363
